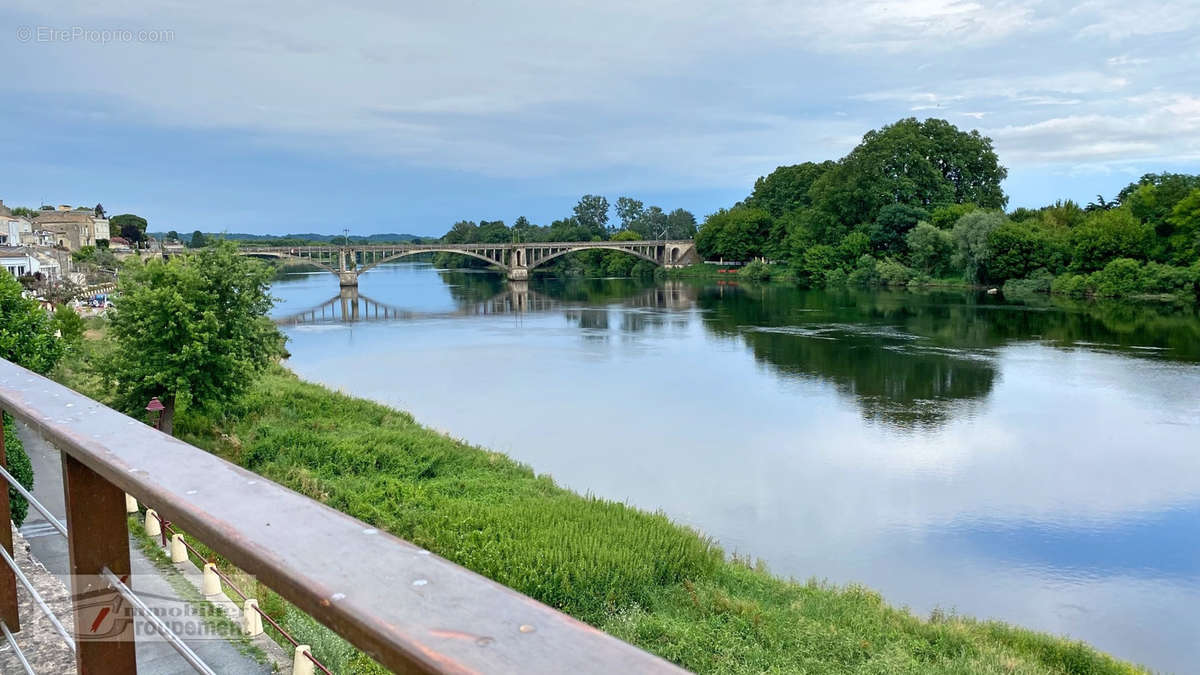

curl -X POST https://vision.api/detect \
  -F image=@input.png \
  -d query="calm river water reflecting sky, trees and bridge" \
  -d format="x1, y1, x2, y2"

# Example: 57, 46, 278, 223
274, 263, 1200, 673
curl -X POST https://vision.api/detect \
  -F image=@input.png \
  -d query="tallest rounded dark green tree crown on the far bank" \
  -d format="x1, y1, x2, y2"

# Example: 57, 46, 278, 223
810, 118, 1008, 225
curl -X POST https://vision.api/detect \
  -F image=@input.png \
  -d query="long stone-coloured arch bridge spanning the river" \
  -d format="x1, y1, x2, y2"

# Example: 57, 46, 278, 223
239, 239, 700, 286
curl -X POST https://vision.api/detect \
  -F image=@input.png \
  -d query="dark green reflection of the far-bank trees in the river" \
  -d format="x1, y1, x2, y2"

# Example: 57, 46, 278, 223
697, 281, 1200, 428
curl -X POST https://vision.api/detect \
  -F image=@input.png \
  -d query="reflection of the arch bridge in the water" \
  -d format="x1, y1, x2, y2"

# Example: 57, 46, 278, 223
275, 281, 696, 325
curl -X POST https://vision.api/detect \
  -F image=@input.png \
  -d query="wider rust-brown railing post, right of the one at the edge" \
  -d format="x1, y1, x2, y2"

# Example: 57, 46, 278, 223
62, 453, 137, 675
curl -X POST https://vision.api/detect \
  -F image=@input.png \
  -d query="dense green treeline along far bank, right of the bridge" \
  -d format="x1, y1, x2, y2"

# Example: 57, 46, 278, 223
684, 118, 1200, 299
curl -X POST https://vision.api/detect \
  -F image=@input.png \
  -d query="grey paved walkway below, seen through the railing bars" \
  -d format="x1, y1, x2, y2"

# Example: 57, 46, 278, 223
14, 424, 270, 675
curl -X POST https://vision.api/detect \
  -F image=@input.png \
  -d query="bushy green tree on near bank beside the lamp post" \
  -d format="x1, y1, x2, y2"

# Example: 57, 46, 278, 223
103, 241, 283, 434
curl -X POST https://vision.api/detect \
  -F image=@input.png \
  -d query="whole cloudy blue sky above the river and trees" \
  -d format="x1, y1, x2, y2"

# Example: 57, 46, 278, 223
0, 0, 1200, 235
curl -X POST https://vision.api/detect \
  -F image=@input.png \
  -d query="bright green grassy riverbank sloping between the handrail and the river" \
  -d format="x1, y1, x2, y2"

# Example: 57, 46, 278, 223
59, 334, 1136, 674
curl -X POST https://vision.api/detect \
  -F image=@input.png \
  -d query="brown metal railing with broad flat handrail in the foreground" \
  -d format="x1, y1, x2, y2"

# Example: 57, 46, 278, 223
0, 359, 680, 675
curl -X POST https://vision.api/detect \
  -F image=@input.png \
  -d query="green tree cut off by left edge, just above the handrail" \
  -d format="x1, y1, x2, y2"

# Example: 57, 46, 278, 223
0, 274, 62, 374
